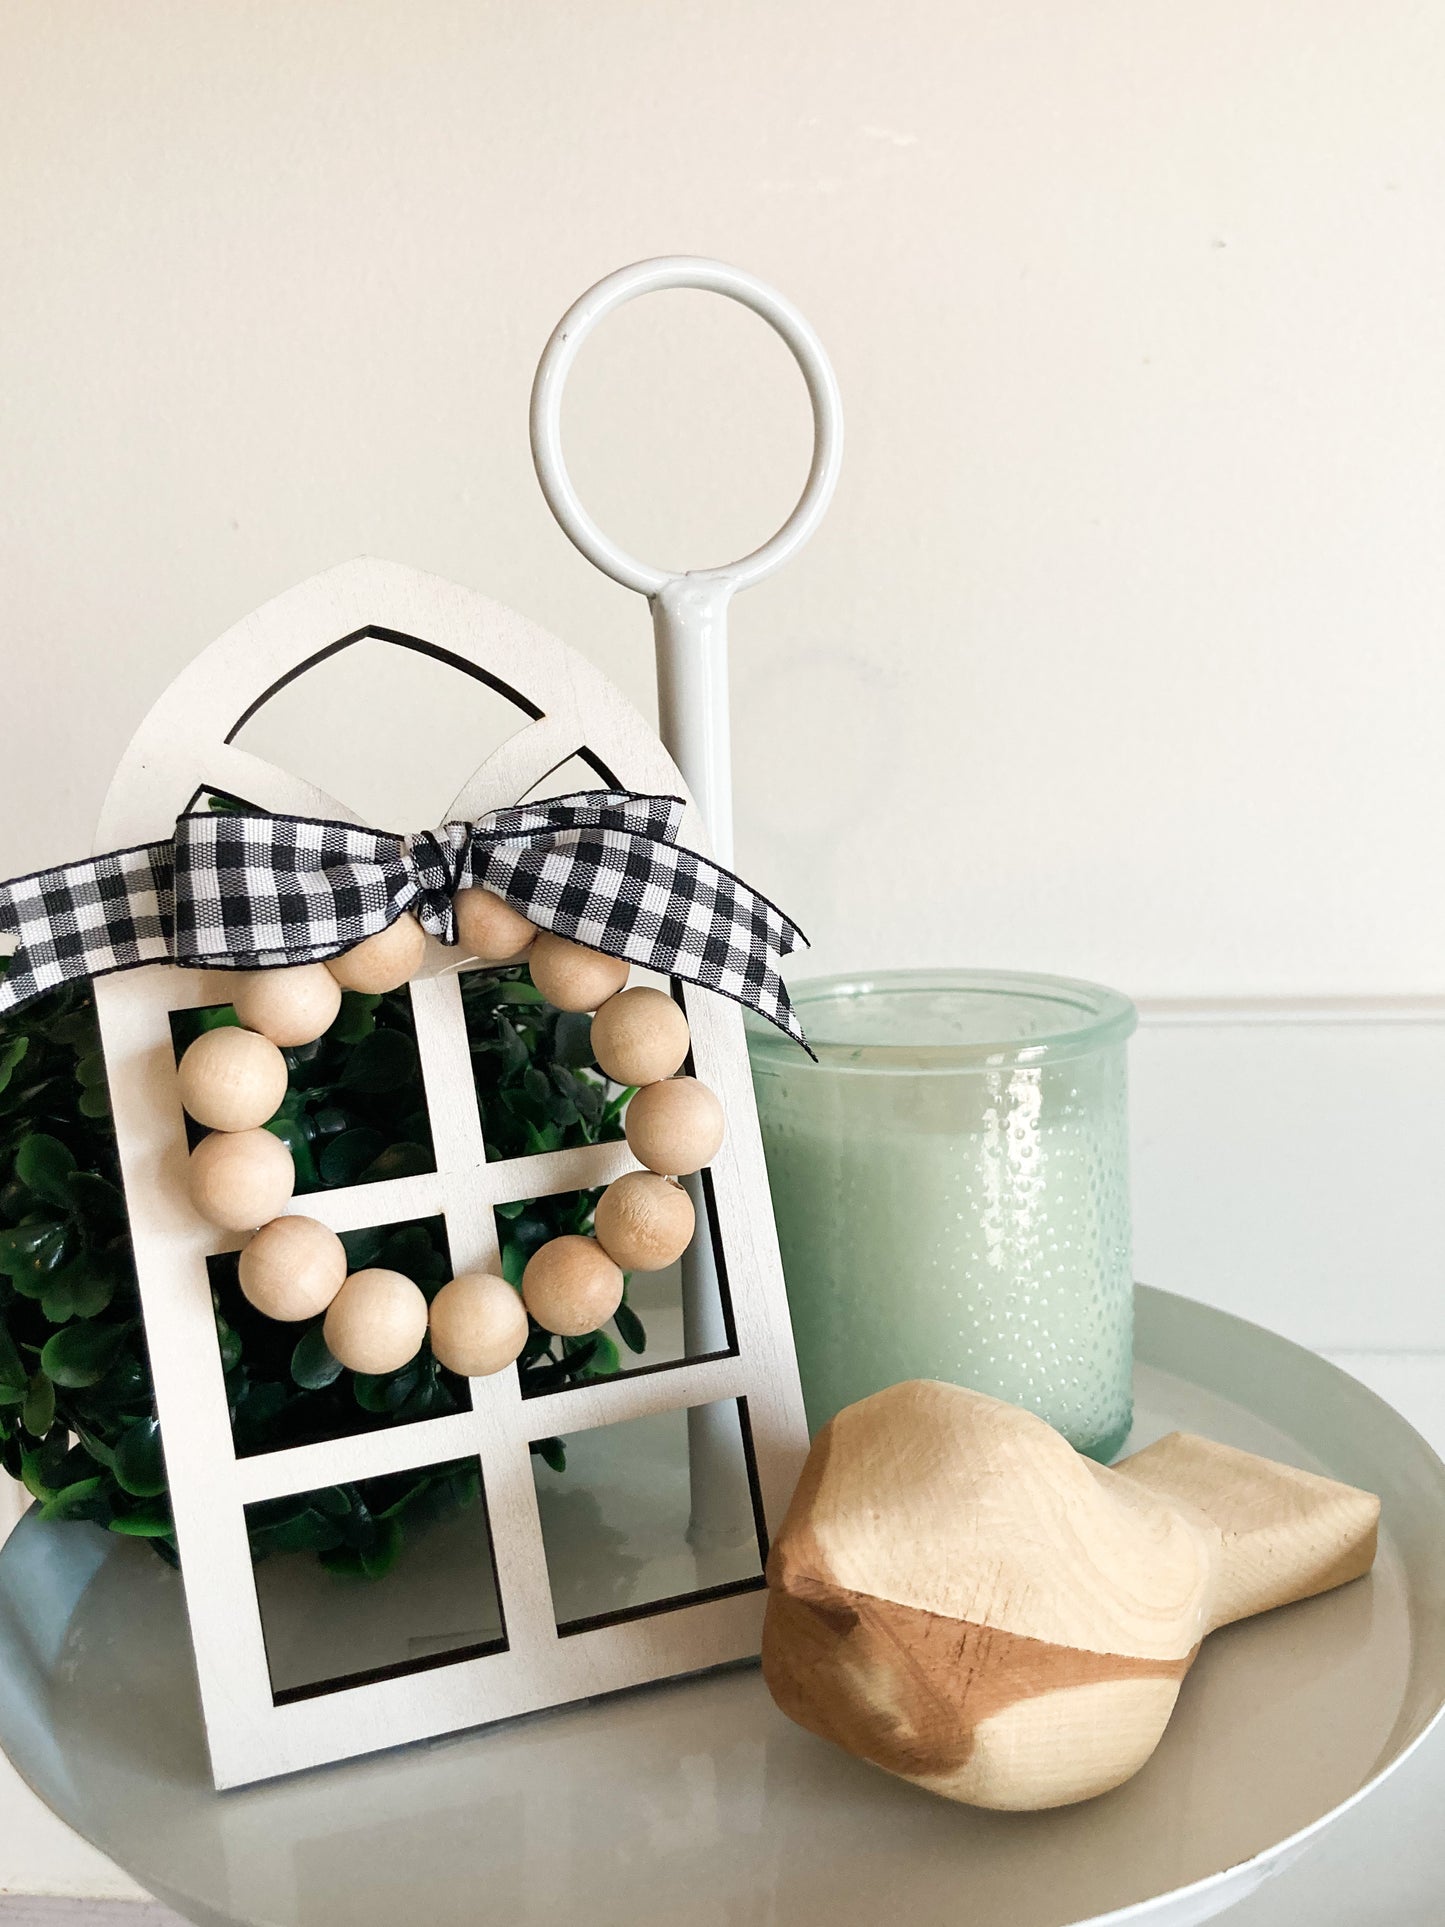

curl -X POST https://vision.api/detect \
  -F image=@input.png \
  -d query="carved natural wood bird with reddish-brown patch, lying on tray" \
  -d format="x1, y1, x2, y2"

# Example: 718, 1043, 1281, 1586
763, 1380, 1379, 1808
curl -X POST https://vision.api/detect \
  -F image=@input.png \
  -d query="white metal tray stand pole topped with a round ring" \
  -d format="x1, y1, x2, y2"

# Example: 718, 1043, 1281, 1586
532, 254, 842, 1540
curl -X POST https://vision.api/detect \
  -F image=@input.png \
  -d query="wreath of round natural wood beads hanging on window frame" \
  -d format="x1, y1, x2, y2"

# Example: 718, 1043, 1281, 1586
177, 888, 724, 1378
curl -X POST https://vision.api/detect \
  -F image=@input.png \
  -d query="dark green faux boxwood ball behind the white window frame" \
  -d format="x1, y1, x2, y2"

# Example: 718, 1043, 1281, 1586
0, 960, 645, 1576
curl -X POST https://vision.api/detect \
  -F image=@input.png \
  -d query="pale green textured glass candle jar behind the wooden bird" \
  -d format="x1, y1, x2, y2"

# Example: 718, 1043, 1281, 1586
749, 971, 1137, 1461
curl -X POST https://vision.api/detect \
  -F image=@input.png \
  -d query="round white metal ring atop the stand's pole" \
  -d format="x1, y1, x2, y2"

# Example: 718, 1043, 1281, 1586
532, 254, 842, 595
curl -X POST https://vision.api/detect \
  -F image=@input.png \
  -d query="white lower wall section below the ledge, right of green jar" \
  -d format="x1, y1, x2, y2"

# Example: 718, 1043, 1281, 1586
1131, 1004, 1445, 1351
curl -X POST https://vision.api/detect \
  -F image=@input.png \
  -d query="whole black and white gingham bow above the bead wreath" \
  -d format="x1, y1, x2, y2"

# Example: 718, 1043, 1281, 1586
0, 790, 803, 1044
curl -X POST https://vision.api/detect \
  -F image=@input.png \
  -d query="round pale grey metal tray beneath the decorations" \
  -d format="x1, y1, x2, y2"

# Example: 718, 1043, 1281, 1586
0, 1287, 1445, 1927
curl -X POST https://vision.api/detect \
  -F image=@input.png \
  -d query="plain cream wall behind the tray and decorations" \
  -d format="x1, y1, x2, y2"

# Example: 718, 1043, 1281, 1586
0, 0, 1445, 1923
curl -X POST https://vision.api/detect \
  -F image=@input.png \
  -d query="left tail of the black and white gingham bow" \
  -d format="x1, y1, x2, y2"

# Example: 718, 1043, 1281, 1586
0, 842, 175, 1016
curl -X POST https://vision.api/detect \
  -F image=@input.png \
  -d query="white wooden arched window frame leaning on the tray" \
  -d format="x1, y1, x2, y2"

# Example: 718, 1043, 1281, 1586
96, 561, 807, 1786
